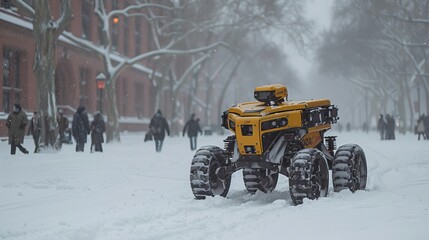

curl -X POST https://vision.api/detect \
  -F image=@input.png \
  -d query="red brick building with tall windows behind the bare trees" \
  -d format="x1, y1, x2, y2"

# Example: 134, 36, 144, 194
0, 0, 154, 136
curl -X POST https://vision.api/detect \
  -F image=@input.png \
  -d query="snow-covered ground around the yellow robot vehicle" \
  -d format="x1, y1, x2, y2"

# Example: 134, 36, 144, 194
0, 132, 429, 240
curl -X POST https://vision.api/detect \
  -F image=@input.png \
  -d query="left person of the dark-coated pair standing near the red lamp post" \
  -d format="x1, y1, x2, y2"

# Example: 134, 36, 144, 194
72, 106, 90, 152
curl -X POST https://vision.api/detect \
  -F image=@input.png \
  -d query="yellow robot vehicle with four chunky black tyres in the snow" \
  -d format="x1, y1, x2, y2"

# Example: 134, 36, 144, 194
190, 84, 367, 204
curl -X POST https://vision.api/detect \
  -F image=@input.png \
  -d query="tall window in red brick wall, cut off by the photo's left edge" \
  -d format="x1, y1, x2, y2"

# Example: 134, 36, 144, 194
2, 48, 22, 113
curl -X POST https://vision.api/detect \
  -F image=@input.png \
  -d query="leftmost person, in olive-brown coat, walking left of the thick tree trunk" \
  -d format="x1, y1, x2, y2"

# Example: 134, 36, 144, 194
6, 103, 28, 155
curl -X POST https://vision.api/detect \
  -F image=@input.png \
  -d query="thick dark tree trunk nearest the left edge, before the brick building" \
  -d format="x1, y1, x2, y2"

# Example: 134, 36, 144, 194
13, 0, 72, 150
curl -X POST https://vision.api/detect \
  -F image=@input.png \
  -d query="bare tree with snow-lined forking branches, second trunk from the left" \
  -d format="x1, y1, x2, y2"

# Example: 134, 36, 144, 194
64, 0, 227, 142
